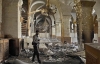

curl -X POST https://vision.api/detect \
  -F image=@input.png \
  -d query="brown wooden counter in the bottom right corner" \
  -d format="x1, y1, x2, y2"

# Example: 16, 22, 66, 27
85, 43, 100, 64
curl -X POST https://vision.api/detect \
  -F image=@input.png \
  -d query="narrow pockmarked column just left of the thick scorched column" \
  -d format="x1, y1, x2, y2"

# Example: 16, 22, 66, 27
74, 0, 83, 50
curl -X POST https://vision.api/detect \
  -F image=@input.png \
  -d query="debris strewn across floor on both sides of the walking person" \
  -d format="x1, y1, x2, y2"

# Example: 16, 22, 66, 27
0, 40, 86, 64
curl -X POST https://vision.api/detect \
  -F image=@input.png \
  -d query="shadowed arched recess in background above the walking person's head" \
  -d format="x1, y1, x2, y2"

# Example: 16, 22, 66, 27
33, 12, 52, 37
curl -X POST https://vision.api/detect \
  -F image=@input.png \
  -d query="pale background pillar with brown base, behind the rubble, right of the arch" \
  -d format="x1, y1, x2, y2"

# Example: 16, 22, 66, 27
63, 15, 71, 43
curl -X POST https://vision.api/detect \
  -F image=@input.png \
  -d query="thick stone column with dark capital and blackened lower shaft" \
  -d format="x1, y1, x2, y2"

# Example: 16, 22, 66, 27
80, 0, 95, 43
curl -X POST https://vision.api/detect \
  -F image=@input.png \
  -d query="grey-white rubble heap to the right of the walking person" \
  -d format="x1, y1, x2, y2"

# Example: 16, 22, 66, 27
43, 43, 84, 64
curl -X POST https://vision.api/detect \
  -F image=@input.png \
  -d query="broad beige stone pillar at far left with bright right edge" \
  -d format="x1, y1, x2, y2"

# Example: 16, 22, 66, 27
2, 0, 21, 38
